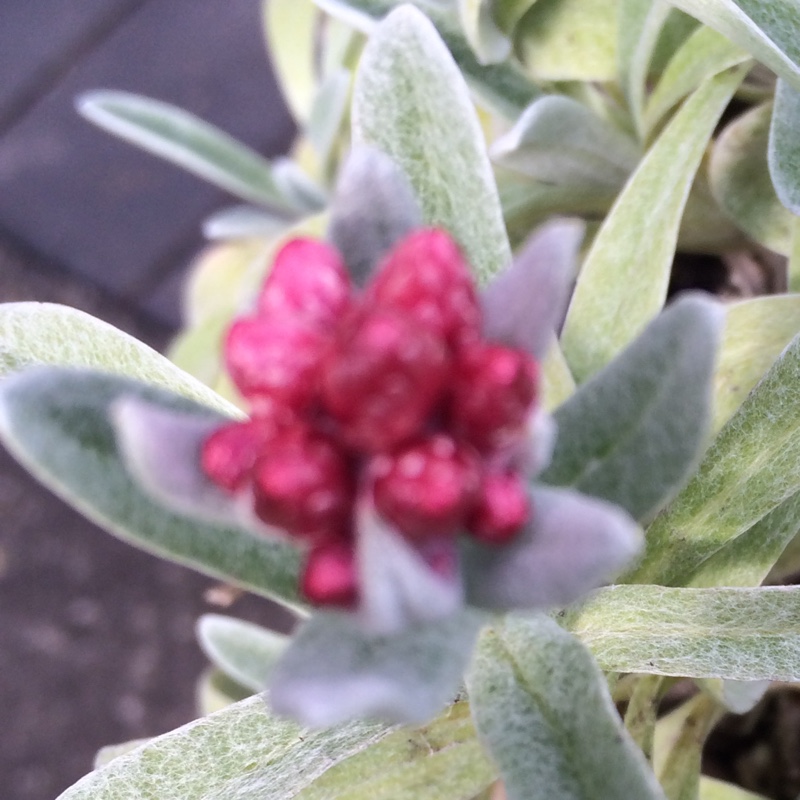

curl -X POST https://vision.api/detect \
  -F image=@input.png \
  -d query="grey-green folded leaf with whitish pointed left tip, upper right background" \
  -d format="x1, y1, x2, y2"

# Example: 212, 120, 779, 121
491, 95, 640, 191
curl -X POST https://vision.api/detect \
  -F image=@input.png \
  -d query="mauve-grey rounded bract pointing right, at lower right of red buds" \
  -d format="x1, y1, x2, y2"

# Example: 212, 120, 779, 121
462, 487, 642, 610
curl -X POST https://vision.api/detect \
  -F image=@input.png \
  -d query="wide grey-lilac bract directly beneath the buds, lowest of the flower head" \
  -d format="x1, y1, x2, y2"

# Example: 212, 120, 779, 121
269, 611, 480, 728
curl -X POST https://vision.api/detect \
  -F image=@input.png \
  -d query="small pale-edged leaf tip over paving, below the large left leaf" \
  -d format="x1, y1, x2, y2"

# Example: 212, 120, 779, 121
197, 614, 289, 692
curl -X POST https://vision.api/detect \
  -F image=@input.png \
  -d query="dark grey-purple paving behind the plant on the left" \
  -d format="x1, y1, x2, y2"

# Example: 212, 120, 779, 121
0, 0, 294, 800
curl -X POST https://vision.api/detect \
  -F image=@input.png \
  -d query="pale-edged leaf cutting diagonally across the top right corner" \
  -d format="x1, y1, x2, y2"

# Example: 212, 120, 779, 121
671, 0, 800, 88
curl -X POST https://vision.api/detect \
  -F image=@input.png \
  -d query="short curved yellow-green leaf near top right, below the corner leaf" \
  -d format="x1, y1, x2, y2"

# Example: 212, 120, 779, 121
644, 26, 750, 133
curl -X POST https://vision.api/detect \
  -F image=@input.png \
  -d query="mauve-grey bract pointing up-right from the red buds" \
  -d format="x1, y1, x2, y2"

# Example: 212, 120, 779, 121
481, 219, 584, 360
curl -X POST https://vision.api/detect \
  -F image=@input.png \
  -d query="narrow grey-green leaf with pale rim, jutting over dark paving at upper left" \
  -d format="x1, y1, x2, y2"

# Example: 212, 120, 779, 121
77, 90, 304, 211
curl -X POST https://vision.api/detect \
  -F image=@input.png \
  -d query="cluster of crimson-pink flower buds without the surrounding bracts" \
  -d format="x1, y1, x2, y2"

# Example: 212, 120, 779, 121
202, 229, 538, 606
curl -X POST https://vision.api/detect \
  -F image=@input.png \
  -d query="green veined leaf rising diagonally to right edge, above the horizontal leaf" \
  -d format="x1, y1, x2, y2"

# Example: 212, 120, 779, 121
628, 328, 800, 586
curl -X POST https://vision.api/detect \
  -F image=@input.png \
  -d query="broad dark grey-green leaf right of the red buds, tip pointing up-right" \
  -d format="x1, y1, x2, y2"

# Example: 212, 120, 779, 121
540, 296, 724, 519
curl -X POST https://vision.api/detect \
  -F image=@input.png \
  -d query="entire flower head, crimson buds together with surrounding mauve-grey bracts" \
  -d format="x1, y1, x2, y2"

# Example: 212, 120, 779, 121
112, 150, 639, 724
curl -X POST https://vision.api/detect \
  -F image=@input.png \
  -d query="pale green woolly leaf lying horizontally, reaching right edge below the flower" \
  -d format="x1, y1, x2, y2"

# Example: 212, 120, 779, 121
561, 586, 800, 681
